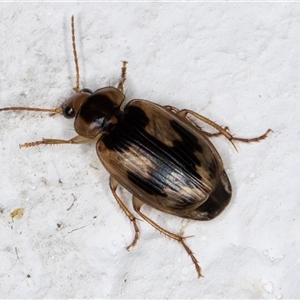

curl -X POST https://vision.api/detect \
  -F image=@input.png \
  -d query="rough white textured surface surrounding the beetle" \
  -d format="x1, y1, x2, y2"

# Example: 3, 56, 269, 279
0, 3, 300, 299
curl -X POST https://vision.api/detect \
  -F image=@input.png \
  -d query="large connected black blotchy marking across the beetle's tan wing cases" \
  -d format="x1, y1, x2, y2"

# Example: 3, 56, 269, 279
101, 106, 201, 197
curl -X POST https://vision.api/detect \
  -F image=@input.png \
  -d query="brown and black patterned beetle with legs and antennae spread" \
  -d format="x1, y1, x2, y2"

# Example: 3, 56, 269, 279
0, 16, 271, 277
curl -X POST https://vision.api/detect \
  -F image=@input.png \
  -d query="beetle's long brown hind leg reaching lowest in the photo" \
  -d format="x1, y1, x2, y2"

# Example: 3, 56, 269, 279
132, 196, 202, 277
